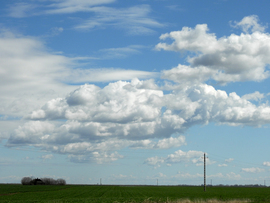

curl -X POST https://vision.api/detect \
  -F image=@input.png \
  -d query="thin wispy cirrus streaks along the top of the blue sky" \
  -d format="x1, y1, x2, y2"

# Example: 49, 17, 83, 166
7, 0, 165, 35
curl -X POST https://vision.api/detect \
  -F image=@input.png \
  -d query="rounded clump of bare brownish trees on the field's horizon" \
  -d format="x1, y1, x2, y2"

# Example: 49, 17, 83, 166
21, 177, 66, 185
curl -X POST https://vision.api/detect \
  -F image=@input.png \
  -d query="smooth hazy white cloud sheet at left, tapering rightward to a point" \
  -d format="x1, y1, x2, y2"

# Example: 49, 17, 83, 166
0, 30, 157, 116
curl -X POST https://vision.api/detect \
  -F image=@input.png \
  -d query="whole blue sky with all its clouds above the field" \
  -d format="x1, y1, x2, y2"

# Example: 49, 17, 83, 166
0, 0, 270, 186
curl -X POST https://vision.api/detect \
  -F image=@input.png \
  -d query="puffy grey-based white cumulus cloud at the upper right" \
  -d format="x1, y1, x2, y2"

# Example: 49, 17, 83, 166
156, 17, 270, 84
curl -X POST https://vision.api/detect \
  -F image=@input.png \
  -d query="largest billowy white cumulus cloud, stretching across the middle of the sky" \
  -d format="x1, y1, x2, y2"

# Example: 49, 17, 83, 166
7, 79, 270, 165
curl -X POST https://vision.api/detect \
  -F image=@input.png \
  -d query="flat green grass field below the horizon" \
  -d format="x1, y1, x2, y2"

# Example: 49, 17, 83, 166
0, 184, 270, 203
